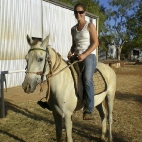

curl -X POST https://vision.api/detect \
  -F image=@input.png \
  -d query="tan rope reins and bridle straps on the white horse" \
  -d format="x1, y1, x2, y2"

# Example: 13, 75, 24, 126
25, 47, 79, 102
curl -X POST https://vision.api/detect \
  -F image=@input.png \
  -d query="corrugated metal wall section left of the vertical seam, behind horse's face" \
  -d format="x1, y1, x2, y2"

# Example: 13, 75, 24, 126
0, 0, 42, 87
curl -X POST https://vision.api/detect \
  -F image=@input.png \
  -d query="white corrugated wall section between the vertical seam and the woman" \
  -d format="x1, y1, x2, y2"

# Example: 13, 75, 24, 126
43, 2, 96, 58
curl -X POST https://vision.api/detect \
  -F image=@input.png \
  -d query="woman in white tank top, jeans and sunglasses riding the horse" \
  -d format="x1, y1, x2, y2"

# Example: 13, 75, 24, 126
68, 3, 98, 120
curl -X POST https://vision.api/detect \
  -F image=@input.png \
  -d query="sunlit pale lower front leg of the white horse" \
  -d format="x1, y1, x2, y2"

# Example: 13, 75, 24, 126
65, 114, 73, 142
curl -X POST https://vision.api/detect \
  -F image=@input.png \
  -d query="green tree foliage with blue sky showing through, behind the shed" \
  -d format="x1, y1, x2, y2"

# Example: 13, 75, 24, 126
59, 0, 142, 57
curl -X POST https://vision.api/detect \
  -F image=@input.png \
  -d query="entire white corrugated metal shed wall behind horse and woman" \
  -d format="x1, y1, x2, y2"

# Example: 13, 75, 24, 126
0, 0, 96, 87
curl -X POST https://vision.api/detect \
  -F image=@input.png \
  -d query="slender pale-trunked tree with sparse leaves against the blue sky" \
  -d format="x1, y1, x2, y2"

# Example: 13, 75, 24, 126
102, 0, 139, 60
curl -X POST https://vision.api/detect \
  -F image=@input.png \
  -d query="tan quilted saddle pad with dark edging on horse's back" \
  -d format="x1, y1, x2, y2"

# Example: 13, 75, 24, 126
67, 62, 107, 95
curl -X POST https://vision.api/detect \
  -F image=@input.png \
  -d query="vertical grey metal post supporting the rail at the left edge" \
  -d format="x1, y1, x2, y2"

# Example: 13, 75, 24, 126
0, 74, 5, 118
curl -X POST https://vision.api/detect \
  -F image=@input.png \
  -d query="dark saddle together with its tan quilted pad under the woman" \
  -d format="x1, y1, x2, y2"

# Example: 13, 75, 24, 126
67, 61, 107, 100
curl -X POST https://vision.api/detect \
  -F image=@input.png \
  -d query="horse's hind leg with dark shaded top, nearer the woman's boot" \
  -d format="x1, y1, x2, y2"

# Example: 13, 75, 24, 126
96, 103, 106, 141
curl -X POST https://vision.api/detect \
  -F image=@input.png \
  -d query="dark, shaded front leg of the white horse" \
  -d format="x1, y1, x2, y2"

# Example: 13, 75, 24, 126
53, 112, 62, 142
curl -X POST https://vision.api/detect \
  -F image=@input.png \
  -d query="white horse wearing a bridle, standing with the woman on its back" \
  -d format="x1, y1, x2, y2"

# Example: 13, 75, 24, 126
22, 35, 116, 142
